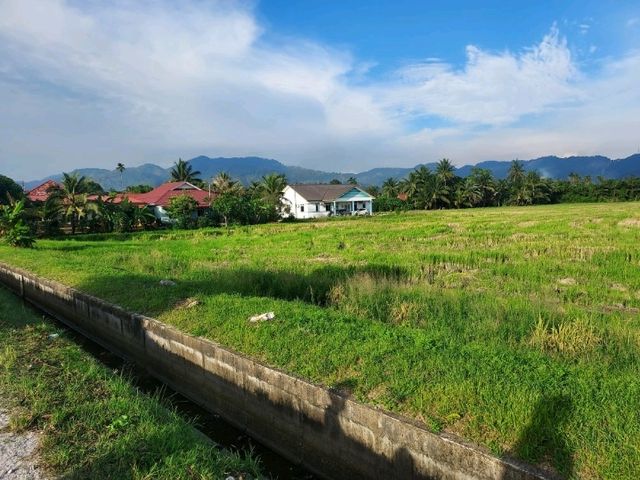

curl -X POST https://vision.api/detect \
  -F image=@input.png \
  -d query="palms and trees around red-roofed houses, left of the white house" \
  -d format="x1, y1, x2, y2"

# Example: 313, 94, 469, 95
0, 159, 287, 247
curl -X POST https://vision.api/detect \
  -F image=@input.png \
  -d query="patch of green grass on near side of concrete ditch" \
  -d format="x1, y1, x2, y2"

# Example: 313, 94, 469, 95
0, 288, 258, 479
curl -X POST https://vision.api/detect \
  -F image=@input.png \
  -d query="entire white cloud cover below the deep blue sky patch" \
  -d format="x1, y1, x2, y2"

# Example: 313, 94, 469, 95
0, 0, 640, 179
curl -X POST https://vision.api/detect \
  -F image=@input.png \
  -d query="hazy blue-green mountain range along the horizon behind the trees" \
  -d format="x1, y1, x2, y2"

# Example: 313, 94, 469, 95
24, 153, 640, 190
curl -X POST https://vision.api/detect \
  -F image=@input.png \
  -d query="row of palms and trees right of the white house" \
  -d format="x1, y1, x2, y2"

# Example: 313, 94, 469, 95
370, 158, 640, 212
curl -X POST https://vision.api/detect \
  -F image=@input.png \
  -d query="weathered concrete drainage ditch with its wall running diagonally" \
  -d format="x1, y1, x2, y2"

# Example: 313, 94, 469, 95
0, 264, 551, 480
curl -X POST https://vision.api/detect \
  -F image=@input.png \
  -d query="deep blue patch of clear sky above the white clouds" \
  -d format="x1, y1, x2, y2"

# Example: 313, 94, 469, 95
257, 0, 640, 69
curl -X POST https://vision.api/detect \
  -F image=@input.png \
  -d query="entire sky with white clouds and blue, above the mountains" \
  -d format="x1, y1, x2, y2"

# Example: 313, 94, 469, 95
0, 0, 640, 180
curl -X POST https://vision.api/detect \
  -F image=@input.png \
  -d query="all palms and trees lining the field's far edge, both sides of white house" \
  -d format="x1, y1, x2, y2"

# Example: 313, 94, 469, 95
0, 159, 640, 247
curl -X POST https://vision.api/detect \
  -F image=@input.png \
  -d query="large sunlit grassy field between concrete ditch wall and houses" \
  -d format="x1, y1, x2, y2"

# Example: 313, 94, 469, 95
0, 203, 640, 479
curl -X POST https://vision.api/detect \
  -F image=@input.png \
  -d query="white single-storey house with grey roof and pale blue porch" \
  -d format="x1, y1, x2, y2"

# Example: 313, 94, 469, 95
282, 184, 373, 219
